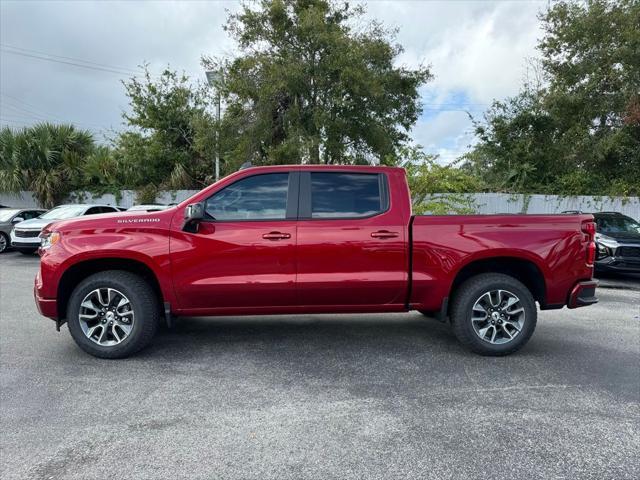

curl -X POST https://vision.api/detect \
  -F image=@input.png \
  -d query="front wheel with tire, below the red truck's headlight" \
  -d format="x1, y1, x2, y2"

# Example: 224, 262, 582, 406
67, 270, 160, 358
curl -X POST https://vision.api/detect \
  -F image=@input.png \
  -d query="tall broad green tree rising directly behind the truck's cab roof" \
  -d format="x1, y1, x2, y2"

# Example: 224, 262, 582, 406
208, 0, 431, 166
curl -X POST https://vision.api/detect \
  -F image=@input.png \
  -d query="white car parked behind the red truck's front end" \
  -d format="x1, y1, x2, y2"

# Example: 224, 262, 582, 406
11, 204, 119, 255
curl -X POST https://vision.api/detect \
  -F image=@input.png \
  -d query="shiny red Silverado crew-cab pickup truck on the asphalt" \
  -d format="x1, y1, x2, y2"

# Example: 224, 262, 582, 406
35, 165, 597, 358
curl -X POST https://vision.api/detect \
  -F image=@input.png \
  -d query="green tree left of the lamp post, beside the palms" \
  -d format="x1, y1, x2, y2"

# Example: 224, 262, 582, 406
119, 70, 216, 198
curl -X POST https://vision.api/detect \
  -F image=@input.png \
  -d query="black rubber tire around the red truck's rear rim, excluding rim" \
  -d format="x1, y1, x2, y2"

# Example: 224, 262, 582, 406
451, 273, 538, 356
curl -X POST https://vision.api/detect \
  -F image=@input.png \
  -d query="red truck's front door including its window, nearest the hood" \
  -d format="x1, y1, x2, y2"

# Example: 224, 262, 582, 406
171, 172, 298, 313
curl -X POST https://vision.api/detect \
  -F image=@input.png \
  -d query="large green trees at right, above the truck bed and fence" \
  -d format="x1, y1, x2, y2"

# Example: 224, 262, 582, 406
466, 0, 640, 195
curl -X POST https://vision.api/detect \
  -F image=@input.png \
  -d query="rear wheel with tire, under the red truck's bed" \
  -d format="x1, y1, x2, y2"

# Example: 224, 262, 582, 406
451, 273, 537, 356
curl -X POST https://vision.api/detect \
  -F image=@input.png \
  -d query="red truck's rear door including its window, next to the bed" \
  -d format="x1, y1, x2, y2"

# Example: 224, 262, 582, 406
298, 170, 407, 308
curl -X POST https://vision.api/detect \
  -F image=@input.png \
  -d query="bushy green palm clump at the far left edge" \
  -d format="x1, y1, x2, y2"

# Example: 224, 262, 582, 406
0, 123, 95, 208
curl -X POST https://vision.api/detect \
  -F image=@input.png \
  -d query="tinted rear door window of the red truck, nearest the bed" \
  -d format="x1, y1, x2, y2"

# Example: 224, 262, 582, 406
311, 172, 385, 218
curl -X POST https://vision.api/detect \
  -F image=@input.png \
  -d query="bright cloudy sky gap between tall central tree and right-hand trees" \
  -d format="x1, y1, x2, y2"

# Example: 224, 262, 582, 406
367, 1, 544, 163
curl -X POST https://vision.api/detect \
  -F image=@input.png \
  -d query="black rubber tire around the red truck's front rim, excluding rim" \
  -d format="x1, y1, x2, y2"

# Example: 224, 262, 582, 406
67, 270, 160, 358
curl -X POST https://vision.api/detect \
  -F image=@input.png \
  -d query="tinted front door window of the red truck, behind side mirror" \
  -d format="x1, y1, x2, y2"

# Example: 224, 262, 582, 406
205, 173, 289, 220
